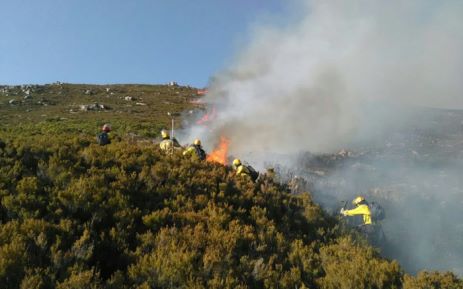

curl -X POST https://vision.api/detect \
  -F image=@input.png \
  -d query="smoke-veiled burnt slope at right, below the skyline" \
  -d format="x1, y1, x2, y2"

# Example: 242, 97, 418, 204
286, 109, 463, 276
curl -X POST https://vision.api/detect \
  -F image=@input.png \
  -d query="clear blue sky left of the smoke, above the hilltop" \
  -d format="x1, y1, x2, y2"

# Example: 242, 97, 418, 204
0, 0, 287, 87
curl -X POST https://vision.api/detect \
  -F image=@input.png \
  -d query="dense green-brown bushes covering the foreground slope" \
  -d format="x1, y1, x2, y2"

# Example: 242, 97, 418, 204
0, 136, 461, 288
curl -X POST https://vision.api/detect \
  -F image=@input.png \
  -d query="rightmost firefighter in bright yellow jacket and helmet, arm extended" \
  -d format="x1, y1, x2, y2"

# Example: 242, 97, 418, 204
340, 196, 384, 245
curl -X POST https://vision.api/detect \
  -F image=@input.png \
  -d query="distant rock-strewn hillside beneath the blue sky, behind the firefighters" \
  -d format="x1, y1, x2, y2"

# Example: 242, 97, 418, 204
0, 82, 198, 136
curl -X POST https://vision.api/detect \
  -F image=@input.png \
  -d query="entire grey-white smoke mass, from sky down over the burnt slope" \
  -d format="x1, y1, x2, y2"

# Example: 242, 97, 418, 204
193, 0, 463, 274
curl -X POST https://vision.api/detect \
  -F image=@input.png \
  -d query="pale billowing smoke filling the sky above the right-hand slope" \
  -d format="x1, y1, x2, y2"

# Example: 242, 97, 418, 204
205, 0, 463, 155
